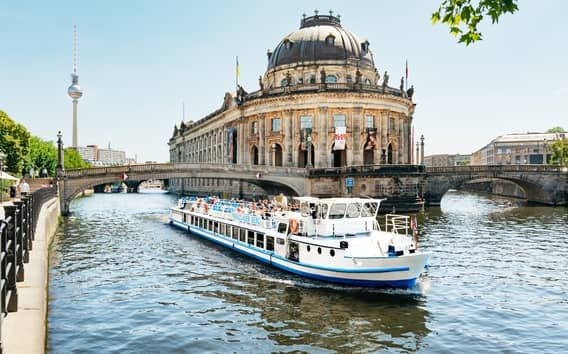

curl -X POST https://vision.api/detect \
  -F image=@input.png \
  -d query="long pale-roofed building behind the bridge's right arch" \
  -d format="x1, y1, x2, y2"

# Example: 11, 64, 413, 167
471, 133, 568, 165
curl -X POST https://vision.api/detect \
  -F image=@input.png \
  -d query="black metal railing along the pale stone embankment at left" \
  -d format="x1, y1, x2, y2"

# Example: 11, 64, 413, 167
0, 186, 57, 353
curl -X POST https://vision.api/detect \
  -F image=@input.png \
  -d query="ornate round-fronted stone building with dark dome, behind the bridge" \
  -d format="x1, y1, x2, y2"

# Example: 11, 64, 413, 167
169, 12, 415, 196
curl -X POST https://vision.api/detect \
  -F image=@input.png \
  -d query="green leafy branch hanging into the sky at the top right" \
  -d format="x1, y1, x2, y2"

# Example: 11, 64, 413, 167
432, 0, 519, 45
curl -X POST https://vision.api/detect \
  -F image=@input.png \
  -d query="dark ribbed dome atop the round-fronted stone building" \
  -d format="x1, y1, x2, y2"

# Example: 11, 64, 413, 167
268, 14, 375, 70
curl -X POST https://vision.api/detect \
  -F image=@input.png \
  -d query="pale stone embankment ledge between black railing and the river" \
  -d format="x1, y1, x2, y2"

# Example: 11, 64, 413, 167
2, 198, 60, 354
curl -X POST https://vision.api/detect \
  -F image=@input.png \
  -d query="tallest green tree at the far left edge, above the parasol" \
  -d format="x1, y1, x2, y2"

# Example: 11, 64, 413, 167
0, 111, 30, 174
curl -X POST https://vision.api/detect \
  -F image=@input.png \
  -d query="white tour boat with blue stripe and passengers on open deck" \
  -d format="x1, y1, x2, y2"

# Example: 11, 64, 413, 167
169, 197, 430, 288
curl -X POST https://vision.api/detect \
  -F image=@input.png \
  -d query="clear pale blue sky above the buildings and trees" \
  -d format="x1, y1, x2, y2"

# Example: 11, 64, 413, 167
0, 0, 568, 162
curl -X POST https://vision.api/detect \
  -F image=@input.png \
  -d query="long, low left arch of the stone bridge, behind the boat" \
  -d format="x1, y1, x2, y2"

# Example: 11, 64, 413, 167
58, 163, 309, 215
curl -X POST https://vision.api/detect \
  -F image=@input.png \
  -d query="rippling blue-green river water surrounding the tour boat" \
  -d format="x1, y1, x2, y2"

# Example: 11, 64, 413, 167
47, 192, 568, 353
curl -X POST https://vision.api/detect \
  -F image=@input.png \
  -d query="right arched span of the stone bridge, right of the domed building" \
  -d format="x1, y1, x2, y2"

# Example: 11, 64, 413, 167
422, 165, 568, 205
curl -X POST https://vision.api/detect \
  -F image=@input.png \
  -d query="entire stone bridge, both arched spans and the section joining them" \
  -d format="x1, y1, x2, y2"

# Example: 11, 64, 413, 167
58, 163, 568, 214
